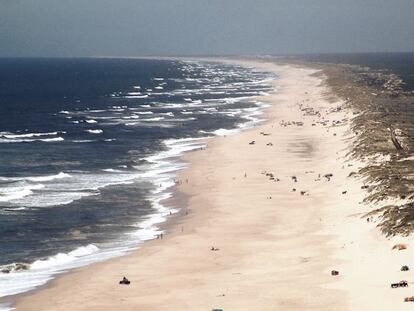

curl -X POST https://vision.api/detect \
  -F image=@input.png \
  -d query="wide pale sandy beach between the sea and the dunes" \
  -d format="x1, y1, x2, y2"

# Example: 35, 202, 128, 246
9, 59, 414, 311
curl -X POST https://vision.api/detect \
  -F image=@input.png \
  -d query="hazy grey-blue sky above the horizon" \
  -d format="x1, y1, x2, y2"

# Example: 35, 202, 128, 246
0, 0, 414, 56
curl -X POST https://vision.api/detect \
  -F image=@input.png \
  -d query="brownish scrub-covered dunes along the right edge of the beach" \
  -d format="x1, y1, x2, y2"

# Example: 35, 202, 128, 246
320, 65, 414, 236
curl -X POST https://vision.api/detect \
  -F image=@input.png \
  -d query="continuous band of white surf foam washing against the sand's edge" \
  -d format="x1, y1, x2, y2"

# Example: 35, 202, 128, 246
0, 138, 209, 304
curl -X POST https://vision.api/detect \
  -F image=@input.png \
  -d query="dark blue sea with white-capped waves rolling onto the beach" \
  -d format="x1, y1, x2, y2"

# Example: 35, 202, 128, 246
0, 59, 274, 296
